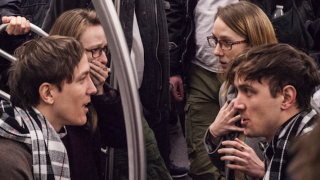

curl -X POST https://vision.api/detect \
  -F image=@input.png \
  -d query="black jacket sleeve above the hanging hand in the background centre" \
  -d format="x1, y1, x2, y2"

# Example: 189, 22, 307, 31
165, 0, 197, 76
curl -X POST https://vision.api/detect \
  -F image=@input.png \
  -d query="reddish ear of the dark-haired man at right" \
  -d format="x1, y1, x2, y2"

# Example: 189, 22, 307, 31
281, 85, 297, 109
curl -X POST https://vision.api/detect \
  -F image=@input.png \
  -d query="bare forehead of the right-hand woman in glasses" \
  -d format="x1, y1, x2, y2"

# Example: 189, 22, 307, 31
212, 17, 242, 40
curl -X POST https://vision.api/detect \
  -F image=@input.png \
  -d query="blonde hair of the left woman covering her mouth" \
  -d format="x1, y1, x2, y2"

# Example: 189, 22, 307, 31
49, 9, 101, 132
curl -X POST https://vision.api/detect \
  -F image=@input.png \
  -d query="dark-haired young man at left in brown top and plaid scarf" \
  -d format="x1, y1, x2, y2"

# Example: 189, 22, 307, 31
0, 36, 97, 180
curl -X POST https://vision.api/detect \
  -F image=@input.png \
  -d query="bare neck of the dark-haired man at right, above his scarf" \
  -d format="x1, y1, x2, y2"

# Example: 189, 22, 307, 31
266, 106, 301, 144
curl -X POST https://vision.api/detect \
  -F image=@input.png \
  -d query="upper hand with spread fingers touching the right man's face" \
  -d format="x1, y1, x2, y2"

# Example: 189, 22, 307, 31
210, 100, 243, 139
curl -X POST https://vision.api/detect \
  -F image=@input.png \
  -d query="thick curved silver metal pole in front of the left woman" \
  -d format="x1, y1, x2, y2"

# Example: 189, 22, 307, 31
92, 0, 146, 180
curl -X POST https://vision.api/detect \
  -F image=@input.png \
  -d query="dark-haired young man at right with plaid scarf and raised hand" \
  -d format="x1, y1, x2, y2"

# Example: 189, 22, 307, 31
212, 44, 320, 180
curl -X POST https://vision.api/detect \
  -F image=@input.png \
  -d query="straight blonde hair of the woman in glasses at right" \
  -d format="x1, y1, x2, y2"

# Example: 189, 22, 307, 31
214, 1, 278, 97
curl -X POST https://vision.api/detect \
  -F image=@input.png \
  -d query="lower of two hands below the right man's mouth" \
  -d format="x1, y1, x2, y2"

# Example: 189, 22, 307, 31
218, 138, 265, 179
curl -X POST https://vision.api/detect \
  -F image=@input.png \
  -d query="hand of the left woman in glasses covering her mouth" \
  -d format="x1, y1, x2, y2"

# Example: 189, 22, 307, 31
89, 61, 109, 95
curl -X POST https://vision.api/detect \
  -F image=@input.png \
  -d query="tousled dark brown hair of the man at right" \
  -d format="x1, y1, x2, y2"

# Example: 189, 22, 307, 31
226, 44, 320, 110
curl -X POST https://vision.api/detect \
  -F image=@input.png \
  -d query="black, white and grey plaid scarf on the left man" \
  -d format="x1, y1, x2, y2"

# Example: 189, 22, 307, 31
0, 101, 70, 180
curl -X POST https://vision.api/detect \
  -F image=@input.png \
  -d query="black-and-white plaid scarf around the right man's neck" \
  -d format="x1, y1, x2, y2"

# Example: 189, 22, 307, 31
261, 109, 317, 180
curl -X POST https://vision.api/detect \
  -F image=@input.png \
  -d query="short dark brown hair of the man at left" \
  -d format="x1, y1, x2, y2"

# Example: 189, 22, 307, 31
8, 36, 84, 110
